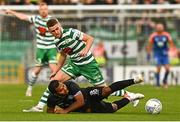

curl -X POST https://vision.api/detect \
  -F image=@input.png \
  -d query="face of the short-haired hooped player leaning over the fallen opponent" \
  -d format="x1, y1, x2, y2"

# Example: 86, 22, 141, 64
48, 23, 62, 38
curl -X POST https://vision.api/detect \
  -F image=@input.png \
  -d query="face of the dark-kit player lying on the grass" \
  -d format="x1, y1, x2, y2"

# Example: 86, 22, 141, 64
56, 83, 69, 95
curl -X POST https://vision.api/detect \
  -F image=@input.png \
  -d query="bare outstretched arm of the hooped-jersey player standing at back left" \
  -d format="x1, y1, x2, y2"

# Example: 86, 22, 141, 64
5, 9, 29, 21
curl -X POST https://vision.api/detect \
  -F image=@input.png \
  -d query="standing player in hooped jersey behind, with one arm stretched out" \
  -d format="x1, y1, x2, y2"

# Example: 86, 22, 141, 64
6, 3, 57, 96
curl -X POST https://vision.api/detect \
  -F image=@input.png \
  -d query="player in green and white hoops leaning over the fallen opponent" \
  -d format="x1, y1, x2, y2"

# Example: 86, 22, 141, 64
23, 19, 144, 112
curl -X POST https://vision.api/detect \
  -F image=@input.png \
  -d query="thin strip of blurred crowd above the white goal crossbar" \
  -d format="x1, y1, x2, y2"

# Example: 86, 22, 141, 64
0, 0, 180, 5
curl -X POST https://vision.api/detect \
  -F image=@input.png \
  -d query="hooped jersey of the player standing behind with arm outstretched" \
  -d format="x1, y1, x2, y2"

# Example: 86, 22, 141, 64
29, 15, 56, 49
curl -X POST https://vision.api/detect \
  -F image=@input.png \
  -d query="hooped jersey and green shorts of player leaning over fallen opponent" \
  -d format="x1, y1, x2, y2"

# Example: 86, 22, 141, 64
55, 28, 104, 86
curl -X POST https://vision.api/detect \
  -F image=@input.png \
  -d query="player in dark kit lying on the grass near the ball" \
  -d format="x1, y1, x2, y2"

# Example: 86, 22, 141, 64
47, 75, 144, 114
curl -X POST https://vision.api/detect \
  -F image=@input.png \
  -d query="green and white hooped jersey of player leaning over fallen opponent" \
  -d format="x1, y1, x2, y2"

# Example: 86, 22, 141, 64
55, 28, 94, 65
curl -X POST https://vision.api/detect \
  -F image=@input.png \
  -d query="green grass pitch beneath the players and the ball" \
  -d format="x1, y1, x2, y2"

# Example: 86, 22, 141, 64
0, 84, 180, 121
